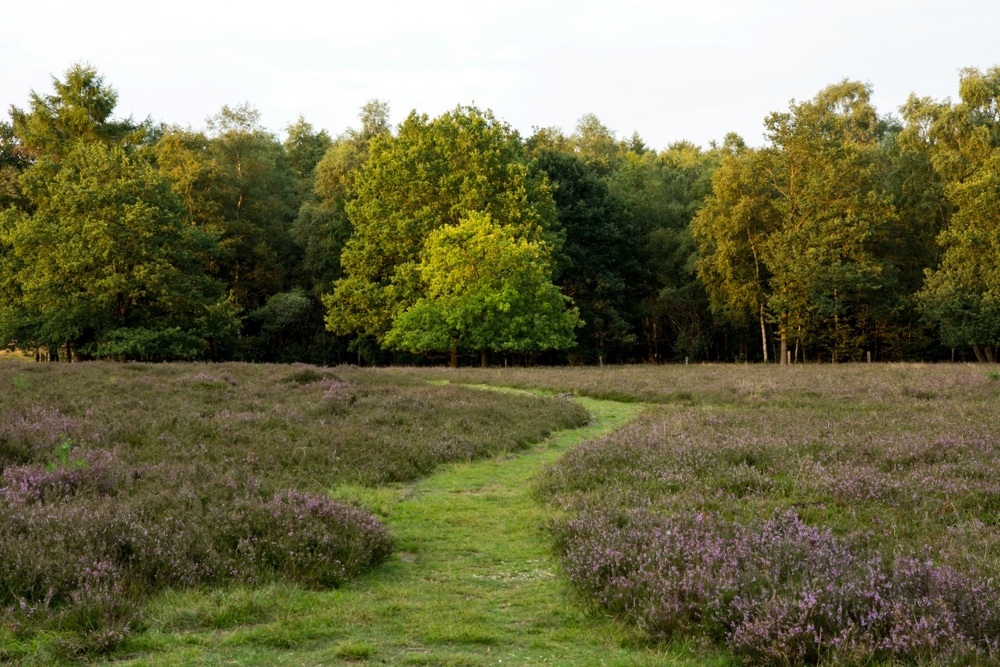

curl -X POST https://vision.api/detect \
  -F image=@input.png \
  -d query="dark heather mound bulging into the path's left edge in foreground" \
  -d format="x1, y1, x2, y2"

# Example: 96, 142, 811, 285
0, 467, 392, 650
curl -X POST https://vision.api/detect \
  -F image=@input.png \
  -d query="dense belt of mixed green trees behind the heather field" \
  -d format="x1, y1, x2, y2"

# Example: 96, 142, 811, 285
0, 64, 1000, 366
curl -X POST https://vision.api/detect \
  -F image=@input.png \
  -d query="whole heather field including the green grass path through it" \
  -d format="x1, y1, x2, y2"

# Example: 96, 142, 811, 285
0, 359, 1000, 665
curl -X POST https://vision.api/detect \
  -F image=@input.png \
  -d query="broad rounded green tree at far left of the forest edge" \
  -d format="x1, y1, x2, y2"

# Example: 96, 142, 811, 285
0, 142, 227, 354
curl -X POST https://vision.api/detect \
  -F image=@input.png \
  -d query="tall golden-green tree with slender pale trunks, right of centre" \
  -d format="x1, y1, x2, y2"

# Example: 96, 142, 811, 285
696, 81, 898, 363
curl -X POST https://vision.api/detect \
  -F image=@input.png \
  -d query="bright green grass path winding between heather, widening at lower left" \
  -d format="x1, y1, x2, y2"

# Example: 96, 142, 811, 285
116, 398, 712, 666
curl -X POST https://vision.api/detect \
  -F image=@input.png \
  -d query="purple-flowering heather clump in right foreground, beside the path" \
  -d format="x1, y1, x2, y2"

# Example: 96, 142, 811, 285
555, 510, 1000, 665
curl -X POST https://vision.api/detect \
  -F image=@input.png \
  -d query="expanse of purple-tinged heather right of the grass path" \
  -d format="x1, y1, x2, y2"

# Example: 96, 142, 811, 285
529, 366, 1000, 665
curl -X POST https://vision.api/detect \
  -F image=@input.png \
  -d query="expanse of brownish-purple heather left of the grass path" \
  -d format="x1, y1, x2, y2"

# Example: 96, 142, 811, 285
0, 363, 586, 660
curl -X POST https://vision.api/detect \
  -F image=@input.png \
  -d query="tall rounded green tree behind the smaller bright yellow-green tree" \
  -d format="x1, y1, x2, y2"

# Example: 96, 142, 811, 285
324, 107, 561, 360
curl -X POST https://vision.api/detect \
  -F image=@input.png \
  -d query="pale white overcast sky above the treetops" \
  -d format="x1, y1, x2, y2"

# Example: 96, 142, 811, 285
0, 0, 1000, 149
